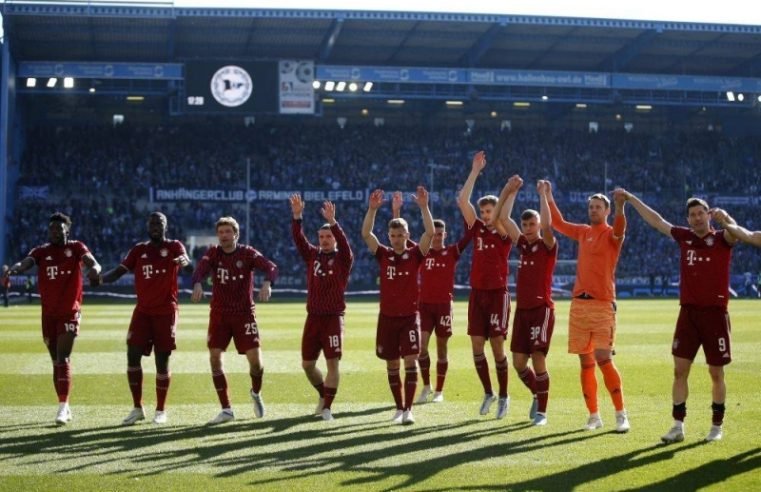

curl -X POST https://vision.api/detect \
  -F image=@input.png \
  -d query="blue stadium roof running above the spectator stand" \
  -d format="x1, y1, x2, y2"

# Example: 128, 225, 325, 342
2, 1, 761, 77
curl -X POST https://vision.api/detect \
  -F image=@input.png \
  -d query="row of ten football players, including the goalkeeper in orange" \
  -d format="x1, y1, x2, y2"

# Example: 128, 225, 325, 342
8, 152, 761, 443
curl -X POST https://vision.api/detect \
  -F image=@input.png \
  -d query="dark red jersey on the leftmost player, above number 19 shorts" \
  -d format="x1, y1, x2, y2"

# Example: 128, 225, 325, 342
29, 241, 90, 316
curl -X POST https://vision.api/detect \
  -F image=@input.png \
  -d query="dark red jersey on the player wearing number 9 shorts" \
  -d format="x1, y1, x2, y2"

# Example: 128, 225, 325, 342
671, 227, 732, 307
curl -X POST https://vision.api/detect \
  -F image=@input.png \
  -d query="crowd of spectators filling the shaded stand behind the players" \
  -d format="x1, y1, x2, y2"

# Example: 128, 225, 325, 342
8, 122, 761, 290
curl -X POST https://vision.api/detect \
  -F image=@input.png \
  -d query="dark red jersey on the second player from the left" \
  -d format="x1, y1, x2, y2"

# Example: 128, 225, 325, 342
122, 239, 185, 315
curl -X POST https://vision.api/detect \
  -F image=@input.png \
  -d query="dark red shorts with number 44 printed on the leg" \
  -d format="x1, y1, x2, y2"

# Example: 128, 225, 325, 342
468, 287, 510, 338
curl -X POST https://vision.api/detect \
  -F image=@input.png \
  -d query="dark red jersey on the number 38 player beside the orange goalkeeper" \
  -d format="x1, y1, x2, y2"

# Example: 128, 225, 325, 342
515, 234, 558, 309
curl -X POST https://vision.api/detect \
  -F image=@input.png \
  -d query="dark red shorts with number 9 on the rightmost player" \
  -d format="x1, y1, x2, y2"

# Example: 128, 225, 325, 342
671, 306, 732, 366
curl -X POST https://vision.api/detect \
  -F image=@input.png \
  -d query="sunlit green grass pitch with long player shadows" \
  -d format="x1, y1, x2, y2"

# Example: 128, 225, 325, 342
0, 300, 761, 491
